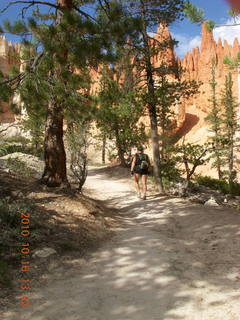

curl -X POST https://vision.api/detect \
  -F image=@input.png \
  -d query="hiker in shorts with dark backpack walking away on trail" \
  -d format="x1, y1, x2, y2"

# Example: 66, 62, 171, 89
131, 146, 150, 200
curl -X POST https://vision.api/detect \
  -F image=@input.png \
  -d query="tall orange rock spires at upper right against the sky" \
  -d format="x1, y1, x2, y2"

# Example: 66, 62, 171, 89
181, 23, 240, 112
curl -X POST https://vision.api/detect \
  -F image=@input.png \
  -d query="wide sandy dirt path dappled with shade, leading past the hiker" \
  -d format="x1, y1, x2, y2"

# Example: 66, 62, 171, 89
3, 170, 240, 320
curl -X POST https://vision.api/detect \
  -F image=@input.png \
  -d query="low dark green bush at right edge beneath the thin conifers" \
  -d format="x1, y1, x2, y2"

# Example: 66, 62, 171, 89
196, 176, 240, 196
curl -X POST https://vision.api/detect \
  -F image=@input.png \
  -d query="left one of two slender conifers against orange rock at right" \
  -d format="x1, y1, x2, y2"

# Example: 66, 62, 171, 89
206, 59, 223, 179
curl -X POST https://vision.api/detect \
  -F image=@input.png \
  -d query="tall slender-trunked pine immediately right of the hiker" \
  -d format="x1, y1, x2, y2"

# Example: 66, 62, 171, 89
126, 0, 199, 192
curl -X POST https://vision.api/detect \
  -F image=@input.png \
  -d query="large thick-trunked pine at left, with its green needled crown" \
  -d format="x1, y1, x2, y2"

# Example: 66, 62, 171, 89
1, 0, 139, 186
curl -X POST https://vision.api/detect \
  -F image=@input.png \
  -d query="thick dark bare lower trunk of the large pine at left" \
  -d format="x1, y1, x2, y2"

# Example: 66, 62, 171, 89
41, 102, 68, 187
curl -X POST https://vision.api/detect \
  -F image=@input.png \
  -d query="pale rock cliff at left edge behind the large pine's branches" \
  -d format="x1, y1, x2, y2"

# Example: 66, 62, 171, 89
0, 36, 20, 122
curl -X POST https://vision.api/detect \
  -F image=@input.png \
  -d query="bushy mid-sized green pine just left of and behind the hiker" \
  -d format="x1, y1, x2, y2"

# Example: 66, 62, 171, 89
97, 52, 146, 166
